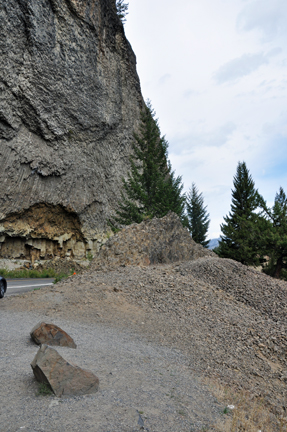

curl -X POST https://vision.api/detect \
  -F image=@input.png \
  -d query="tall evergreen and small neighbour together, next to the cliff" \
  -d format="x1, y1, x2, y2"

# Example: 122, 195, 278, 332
109, 102, 210, 247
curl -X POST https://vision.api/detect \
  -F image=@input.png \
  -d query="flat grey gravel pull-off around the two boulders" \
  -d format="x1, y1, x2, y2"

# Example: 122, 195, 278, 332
0, 310, 222, 432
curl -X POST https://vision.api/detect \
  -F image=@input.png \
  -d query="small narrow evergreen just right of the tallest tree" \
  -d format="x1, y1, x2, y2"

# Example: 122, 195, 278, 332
186, 183, 210, 247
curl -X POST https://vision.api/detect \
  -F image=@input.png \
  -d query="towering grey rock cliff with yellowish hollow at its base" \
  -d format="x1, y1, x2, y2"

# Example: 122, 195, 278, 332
0, 0, 143, 258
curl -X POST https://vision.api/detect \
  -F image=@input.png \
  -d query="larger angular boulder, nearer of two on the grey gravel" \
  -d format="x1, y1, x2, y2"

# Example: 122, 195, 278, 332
31, 345, 99, 397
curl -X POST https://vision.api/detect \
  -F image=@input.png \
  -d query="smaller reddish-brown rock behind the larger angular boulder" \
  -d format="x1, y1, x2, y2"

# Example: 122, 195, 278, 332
30, 322, 77, 348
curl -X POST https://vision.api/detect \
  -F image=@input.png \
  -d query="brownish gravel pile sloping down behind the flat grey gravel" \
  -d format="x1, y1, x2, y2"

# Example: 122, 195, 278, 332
0, 258, 287, 422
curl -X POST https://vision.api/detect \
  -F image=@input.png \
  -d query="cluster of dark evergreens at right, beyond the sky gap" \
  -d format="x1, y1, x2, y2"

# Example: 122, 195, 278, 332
215, 162, 287, 278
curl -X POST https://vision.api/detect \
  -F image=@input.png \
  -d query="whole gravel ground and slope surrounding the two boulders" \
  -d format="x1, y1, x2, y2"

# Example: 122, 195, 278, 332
0, 257, 287, 432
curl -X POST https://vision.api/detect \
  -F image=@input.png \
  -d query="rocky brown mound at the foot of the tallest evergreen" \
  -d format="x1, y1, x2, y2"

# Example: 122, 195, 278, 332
91, 212, 215, 269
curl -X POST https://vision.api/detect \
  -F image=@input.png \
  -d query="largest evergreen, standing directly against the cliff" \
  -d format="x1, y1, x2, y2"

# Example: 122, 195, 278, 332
114, 102, 185, 225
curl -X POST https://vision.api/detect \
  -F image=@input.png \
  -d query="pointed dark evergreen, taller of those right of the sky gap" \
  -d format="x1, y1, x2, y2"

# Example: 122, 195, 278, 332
216, 162, 265, 264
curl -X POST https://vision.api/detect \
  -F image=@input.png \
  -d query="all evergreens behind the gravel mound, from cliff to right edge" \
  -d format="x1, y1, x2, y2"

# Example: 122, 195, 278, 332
109, 102, 287, 278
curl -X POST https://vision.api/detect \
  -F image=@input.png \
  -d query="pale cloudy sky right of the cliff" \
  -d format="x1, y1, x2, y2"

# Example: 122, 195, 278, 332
125, 0, 287, 238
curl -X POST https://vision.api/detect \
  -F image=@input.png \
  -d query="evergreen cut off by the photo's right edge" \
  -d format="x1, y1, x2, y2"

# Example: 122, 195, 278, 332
260, 187, 287, 278
